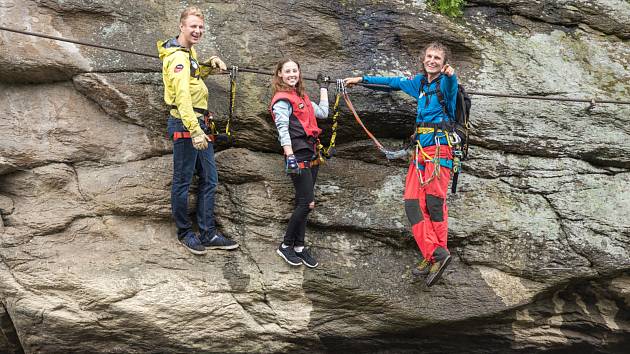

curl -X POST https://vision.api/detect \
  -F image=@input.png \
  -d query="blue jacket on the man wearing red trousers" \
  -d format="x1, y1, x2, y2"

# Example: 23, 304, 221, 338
363, 74, 457, 146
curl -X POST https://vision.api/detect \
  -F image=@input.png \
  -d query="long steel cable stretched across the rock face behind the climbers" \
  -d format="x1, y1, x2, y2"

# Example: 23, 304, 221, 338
0, 26, 630, 106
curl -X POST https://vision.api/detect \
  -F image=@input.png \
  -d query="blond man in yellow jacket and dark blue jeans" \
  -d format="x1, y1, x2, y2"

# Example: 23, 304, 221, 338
157, 7, 238, 254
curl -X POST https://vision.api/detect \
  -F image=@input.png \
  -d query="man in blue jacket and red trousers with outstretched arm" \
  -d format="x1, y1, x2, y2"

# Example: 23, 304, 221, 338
344, 42, 458, 286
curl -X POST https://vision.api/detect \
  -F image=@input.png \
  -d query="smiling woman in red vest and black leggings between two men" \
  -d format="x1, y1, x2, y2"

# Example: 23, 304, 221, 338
270, 59, 328, 268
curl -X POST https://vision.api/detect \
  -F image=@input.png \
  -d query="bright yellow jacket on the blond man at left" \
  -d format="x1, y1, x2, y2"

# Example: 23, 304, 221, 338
157, 38, 217, 137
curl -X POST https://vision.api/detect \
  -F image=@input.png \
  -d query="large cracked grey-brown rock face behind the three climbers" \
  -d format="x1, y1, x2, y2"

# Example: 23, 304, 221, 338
0, 0, 630, 353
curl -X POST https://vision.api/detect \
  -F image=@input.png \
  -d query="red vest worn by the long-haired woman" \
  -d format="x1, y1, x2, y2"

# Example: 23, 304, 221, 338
269, 91, 322, 150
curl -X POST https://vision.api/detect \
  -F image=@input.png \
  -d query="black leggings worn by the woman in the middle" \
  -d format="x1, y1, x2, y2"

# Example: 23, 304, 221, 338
283, 166, 319, 246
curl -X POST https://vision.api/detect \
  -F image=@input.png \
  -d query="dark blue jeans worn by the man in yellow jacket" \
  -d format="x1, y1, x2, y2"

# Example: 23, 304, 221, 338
167, 117, 219, 238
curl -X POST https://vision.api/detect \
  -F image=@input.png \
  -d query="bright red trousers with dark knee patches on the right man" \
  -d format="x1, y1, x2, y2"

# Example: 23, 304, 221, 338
404, 145, 453, 260
